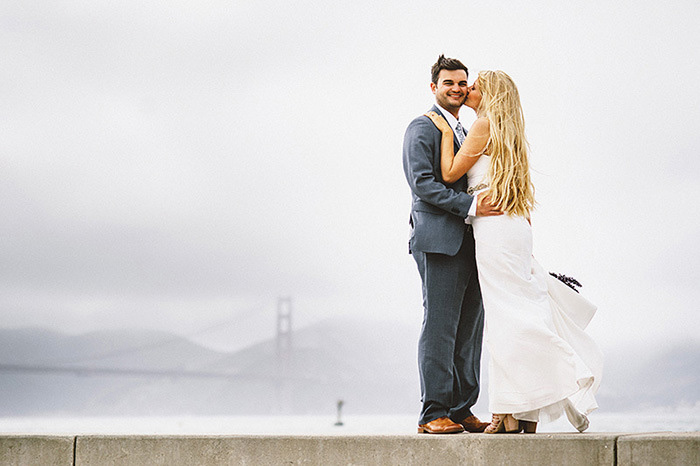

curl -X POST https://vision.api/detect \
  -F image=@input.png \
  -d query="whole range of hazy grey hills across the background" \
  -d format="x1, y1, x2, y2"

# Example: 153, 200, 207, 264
0, 320, 700, 415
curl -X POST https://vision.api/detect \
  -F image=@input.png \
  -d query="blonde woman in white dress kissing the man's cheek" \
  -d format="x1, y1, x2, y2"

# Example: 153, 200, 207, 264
427, 71, 602, 433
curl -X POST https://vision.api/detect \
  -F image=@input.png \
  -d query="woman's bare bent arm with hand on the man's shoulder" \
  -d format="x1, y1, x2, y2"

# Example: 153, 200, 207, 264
426, 112, 489, 183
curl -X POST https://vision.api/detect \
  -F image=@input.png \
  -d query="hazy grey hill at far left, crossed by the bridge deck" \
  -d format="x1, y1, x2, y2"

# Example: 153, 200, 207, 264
0, 329, 230, 414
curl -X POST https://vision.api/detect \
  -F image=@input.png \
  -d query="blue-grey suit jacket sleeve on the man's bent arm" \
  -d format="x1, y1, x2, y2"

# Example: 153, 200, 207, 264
403, 116, 473, 218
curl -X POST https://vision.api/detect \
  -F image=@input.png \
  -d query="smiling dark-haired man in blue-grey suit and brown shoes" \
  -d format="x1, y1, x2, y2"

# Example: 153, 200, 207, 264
403, 55, 500, 434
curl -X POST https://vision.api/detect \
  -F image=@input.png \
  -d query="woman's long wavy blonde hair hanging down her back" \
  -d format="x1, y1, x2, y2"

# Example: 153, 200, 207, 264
477, 71, 535, 217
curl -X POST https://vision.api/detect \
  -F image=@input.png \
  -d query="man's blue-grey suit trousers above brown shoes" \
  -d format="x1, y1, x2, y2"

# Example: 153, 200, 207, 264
413, 226, 484, 424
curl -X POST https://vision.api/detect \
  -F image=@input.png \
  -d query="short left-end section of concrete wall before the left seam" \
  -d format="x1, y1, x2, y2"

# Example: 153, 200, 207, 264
0, 435, 75, 466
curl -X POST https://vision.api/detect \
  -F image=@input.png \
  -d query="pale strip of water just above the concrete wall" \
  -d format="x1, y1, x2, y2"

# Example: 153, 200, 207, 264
0, 406, 700, 435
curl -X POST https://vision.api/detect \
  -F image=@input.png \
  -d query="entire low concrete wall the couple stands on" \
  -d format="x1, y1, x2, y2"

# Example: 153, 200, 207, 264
0, 432, 700, 466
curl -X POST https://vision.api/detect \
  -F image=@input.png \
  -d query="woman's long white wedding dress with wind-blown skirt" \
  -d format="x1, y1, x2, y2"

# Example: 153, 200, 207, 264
467, 155, 603, 431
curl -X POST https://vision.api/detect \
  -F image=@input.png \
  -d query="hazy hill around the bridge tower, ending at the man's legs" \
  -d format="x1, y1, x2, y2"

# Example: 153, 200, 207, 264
197, 320, 420, 414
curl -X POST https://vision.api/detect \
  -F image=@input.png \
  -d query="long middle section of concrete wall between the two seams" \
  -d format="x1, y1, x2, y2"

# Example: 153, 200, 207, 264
76, 434, 619, 466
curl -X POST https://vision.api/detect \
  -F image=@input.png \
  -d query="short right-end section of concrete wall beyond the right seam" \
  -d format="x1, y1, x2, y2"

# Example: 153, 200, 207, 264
617, 432, 700, 466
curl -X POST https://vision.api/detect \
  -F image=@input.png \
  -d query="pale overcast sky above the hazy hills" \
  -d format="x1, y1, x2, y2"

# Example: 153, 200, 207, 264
0, 0, 700, 348
